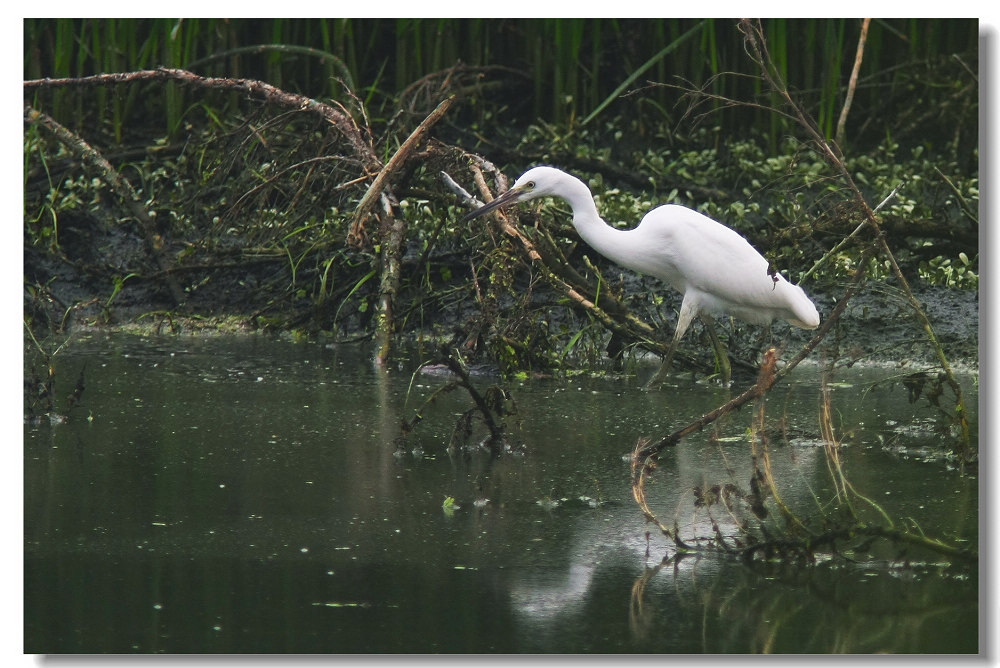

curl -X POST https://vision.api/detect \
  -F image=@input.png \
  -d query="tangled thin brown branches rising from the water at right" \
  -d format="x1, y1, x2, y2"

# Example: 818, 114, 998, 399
632, 22, 978, 562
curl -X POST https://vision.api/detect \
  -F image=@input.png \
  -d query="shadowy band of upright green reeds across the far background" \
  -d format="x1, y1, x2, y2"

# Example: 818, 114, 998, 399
24, 18, 979, 154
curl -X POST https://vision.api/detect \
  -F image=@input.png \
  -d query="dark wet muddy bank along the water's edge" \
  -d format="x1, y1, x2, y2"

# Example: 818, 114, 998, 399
24, 230, 979, 371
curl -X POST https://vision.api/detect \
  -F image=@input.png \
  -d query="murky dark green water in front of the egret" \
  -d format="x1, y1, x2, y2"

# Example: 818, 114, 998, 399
24, 335, 979, 653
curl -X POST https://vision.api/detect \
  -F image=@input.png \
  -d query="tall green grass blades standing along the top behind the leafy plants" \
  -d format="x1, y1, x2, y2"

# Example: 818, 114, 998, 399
24, 18, 979, 140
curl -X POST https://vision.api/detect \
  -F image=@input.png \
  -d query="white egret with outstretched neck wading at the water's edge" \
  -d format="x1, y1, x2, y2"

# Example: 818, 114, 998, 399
465, 166, 819, 385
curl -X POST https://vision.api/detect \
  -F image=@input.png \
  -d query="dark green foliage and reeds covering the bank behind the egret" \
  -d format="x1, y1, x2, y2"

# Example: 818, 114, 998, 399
24, 19, 979, 378
